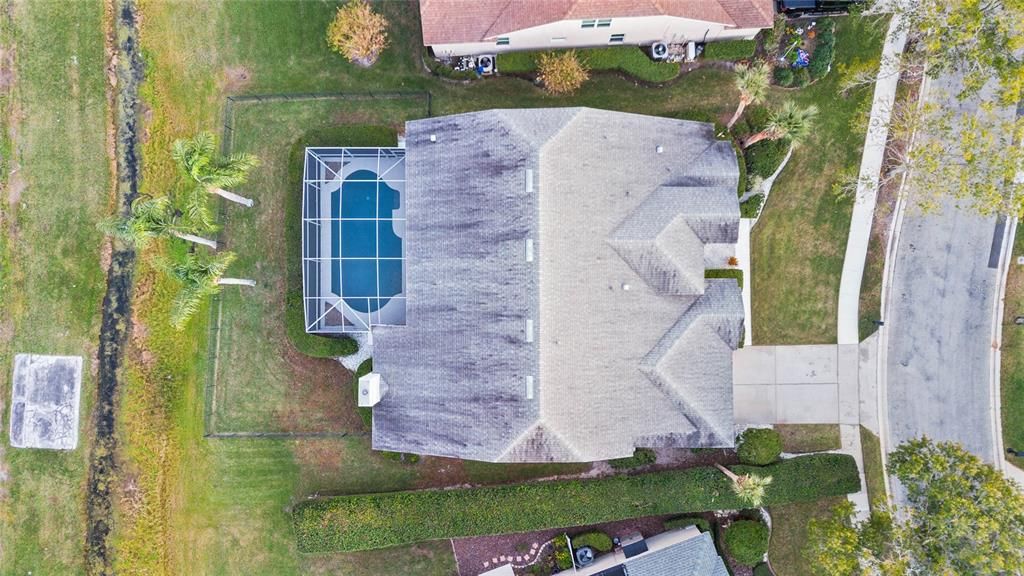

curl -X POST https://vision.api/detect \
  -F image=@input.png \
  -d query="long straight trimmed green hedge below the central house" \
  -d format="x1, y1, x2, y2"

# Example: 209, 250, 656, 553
292, 454, 860, 552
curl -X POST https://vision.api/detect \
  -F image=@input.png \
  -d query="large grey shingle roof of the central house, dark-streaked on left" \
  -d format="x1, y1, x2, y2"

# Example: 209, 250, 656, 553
373, 108, 743, 461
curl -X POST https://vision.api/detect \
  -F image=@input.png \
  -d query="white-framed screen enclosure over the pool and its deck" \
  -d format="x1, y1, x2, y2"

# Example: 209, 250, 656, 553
302, 148, 406, 334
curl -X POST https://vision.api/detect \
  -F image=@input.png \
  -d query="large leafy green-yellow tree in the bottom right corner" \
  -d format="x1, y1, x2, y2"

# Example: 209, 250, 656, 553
808, 438, 1024, 576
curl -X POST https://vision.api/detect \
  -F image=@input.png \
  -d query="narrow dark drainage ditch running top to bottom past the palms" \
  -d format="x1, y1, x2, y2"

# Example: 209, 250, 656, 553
86, 0, 142, 574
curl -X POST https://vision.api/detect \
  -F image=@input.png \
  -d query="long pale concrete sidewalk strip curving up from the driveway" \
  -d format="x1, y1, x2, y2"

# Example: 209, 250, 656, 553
838, 16, 906, 344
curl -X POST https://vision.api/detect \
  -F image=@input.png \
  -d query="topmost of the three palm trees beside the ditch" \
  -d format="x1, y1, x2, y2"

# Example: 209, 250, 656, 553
171, 132, 259, 207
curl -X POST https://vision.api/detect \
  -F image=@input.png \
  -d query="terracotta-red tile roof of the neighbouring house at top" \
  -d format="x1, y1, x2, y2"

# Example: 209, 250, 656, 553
420, 0, 774, 46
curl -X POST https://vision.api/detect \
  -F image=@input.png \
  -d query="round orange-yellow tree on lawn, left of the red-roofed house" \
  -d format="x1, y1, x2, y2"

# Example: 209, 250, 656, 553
327, 0, 388, 68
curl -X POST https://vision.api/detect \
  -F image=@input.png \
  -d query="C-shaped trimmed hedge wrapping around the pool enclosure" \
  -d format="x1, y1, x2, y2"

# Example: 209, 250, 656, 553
283, 125, 397, 358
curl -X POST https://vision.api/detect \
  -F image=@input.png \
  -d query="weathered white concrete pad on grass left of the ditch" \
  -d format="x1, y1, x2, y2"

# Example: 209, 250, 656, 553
10, 354, 82, 450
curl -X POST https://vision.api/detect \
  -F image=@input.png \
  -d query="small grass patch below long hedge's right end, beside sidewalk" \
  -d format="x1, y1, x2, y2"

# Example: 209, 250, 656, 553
768, 498, 843, 576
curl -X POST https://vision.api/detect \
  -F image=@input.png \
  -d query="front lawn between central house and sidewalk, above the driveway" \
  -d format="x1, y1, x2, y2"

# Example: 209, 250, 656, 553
751, 16, 886, 344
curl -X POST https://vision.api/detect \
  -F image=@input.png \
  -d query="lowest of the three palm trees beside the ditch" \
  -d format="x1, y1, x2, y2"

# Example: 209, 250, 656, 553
163, 252, 256, 330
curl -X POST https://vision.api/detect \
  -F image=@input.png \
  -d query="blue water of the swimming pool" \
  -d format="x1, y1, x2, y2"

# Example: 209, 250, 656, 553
331, 170, 402, 313
